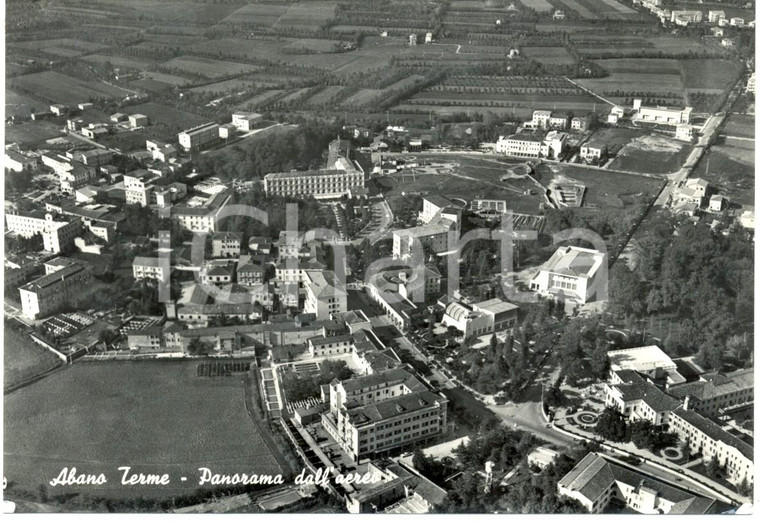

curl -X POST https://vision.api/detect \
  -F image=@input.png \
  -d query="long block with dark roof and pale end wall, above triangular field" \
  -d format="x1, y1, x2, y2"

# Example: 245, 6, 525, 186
18, 263, 91, 320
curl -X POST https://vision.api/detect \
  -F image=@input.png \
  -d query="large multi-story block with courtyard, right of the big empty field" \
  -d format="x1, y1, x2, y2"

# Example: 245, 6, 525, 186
322, 368, 448, 461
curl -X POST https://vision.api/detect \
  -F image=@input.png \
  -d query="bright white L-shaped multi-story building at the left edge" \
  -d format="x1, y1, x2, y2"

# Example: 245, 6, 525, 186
5, 211, 82, 253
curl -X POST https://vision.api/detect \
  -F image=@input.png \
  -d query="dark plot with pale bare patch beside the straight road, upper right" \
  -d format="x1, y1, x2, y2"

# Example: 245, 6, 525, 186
608, 135, 692, 174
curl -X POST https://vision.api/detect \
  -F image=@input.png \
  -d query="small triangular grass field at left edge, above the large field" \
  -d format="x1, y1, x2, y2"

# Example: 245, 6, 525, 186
3, 326, 62, 388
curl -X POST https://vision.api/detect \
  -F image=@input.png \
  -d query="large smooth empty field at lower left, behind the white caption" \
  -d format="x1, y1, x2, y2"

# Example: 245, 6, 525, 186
3, 361, 282, 498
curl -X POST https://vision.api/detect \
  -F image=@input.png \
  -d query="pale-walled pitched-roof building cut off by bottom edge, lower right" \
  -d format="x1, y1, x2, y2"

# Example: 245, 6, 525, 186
557, 452, 717, 514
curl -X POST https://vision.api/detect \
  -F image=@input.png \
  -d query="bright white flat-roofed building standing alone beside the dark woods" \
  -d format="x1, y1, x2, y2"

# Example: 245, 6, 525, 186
530, 246, 607, 304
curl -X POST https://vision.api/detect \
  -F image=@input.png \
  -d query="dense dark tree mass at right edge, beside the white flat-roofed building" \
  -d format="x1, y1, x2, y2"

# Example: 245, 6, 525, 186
609, 212, 754, 369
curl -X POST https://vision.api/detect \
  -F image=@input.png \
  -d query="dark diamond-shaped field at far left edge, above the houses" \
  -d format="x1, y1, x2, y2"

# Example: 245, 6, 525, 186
8, 71, 126, 104
